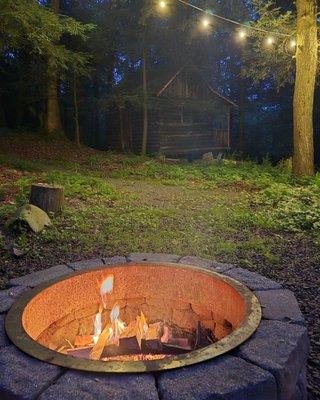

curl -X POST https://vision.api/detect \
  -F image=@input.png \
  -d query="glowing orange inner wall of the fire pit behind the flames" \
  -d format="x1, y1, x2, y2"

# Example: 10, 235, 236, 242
22, 264, 246, 356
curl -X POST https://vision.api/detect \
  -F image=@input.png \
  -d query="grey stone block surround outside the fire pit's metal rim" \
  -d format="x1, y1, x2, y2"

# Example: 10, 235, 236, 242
0, 253, 309, 400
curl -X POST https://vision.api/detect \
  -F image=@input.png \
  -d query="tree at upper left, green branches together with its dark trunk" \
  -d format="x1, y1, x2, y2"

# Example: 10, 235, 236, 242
0, 0, 94, 131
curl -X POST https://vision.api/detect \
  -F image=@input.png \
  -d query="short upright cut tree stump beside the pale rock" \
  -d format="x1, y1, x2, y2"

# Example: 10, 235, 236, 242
30, 183, 64, 215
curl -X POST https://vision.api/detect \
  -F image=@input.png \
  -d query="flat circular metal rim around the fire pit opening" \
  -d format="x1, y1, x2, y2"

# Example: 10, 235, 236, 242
5, 262, 262, 373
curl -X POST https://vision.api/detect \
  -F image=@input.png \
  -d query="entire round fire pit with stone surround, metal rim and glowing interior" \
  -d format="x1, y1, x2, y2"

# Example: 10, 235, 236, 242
0, 253, 309, 400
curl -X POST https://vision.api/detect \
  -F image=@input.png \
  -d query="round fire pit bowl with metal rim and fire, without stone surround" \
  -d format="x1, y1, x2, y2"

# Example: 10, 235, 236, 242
6, 262, 261, 373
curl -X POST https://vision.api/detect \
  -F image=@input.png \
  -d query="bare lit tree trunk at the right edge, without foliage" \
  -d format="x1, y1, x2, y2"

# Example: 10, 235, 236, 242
293, 0, 318, 176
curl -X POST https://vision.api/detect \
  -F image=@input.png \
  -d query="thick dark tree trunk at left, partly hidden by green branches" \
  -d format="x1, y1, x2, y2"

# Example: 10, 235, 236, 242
45, 0, 62, 133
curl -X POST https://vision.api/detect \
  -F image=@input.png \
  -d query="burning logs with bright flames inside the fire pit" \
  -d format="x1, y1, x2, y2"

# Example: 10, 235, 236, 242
61, 275, 207, 361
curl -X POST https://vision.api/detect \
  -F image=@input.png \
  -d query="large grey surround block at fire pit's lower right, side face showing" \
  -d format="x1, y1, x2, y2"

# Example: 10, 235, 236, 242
236, 320, 309, 400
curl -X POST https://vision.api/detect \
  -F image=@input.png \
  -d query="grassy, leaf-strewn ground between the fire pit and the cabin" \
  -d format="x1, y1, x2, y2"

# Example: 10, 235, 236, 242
0, 135, 320, 394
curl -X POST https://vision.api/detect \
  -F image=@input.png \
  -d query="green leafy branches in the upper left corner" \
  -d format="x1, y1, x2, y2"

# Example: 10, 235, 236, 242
0, 0, 94, 74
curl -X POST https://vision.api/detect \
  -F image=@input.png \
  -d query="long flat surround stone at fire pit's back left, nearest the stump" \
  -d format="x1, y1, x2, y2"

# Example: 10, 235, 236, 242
9, 265, 72, 287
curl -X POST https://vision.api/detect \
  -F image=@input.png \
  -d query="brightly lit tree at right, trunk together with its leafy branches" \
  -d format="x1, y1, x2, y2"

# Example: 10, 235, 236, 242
245, 0, 318, 176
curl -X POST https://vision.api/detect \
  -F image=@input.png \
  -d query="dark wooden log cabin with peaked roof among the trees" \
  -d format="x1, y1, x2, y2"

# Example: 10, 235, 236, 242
110, 67, 236, 157
